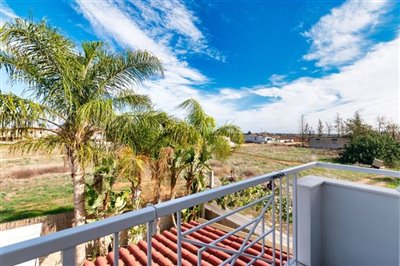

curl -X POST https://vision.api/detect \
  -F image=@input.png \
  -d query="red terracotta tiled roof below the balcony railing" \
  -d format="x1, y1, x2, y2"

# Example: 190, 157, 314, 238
83, 221, 288, 266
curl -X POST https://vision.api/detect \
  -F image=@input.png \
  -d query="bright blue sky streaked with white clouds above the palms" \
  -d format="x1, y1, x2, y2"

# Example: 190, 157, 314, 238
0, 0, 400, 132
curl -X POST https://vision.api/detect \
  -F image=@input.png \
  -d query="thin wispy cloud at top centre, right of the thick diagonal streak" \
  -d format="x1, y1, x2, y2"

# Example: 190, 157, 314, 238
115, 0, 225, 61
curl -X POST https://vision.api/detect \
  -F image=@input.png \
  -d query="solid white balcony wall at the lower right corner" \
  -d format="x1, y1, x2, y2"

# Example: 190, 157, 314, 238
298, 176, 400, 266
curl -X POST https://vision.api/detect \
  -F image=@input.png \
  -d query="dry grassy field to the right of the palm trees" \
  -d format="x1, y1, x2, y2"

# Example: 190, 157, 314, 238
211, 144, 399, 188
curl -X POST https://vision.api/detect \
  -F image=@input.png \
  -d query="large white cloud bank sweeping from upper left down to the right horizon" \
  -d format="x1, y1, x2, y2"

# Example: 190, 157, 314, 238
77, 0, 400, 132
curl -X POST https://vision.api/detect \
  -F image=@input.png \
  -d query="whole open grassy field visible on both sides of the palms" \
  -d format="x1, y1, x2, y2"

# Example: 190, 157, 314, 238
0, 144, 399, 223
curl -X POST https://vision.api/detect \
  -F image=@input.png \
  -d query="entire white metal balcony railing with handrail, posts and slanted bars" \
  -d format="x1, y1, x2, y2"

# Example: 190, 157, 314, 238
0, 162, 400, 266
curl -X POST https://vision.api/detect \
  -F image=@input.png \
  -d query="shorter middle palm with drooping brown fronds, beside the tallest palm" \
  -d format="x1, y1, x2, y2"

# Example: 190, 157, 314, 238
110, 111, 198, 202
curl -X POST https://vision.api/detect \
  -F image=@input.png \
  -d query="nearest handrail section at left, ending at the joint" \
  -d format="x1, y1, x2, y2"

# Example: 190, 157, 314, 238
0, 207, 155, 266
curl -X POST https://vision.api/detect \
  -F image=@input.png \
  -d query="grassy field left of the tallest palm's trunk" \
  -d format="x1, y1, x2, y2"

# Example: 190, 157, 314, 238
0, 145, 73, 223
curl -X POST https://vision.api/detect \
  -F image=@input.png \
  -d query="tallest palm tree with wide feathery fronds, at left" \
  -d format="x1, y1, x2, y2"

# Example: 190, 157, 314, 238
0, 19, 163, 264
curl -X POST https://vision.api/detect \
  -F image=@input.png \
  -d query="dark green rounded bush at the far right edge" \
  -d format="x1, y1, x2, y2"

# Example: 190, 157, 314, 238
340, 131, 400, 167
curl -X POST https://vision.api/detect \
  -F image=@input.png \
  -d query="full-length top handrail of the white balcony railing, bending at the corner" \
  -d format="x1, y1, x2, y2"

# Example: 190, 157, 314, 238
0, 162, 400, 265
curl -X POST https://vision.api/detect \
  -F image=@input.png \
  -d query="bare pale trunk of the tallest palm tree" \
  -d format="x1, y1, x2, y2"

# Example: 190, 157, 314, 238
68, 149, 86, 265
